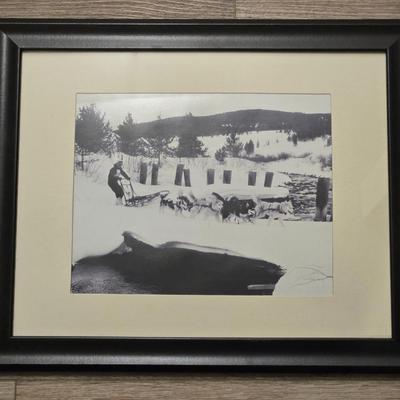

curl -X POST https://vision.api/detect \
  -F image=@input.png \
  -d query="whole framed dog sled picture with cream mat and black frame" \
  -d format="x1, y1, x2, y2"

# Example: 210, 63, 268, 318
0, 20, 400, 369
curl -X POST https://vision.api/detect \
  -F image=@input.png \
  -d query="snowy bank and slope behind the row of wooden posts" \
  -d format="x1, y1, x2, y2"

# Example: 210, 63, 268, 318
84, 131, 332, 190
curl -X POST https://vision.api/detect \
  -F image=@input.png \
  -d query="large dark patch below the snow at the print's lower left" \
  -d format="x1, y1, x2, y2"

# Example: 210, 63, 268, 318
72, 232, 284, 295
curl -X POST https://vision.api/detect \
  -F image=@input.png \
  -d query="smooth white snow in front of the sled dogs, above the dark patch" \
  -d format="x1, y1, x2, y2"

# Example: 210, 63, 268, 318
72, 173, 332, 296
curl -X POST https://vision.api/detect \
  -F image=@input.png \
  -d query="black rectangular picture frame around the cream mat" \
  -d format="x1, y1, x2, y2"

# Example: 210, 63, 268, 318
0, 20, 400, 371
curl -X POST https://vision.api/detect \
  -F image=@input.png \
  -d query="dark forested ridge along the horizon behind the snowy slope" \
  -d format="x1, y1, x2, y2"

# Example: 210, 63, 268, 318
133, 109, 331, 139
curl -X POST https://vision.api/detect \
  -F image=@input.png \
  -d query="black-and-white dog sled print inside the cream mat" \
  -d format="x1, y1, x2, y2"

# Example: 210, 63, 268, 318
71, 93, 334, 297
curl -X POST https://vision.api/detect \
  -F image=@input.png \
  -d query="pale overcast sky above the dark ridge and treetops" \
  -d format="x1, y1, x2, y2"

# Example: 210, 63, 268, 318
76, 93, 331, 128
